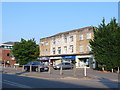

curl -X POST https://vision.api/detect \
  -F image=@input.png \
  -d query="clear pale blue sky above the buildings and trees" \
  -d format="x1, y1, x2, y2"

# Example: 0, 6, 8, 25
2, 2, 118, 43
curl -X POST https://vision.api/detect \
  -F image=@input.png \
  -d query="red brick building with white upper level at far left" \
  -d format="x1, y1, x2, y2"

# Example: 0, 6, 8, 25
0, 42, 16, 66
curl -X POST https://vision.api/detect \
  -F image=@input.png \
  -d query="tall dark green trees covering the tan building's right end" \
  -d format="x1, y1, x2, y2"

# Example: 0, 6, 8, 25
90, 18, 120, 70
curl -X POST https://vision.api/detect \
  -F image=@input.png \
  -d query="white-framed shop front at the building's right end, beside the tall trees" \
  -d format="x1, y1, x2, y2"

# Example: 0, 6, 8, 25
76, 55, 96, 69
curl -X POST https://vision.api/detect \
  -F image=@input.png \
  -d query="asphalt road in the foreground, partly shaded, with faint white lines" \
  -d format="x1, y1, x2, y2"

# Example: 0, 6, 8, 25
2, 74, 118, 88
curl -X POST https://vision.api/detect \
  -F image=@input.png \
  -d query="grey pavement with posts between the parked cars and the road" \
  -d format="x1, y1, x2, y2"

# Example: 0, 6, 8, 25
3, 67, 120, 82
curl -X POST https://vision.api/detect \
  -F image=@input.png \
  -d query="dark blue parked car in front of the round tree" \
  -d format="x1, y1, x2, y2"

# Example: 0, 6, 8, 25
24, 61, 49, 72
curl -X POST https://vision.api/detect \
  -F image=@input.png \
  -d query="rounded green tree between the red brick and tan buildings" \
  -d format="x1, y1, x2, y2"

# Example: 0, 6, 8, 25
11, 38, 39, 65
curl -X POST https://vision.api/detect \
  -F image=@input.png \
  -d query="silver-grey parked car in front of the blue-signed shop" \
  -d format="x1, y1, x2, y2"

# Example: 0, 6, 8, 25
53, 62, 74, 70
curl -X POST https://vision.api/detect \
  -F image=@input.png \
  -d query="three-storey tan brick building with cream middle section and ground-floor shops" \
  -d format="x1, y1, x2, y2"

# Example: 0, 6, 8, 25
39, 26, 96, 68
